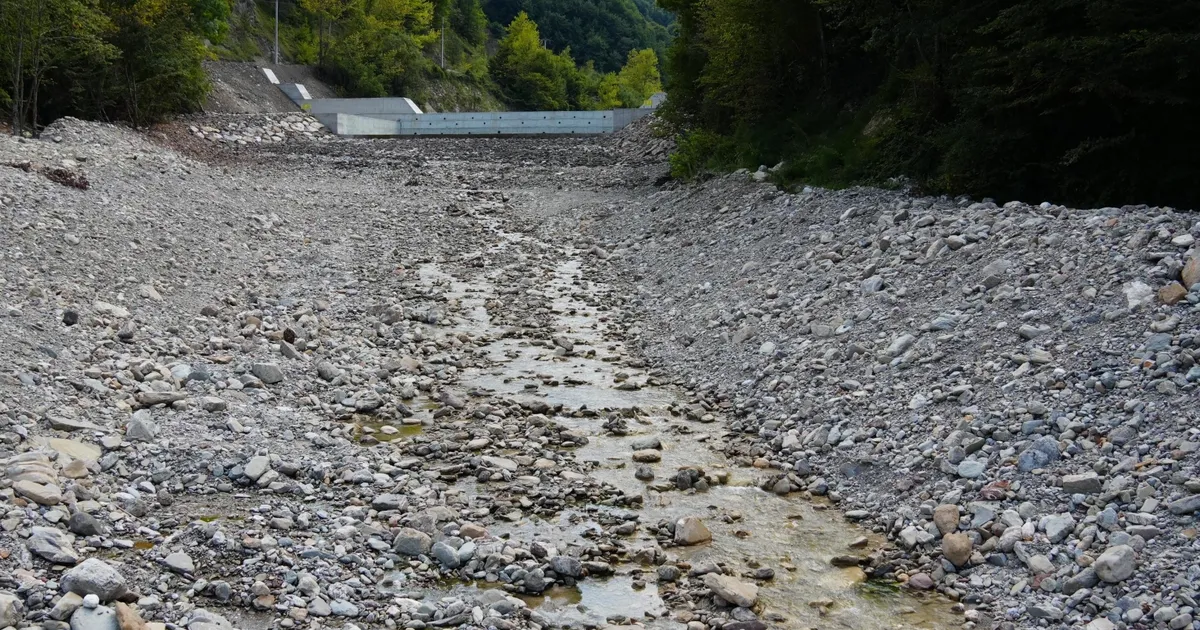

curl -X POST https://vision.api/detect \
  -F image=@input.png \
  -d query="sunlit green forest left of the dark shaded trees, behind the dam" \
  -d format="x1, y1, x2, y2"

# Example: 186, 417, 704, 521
0, 0, 671, 133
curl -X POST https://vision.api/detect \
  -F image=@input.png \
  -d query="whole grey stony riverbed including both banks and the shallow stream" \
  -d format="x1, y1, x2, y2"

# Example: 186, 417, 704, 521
0, 118, 1200, 630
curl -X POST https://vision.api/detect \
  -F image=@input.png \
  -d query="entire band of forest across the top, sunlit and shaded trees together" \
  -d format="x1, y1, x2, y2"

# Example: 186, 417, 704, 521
0, 0, 1200, 206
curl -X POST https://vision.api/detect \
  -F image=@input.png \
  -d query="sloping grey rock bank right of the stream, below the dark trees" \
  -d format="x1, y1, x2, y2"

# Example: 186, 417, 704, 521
581, 173, 1200, 629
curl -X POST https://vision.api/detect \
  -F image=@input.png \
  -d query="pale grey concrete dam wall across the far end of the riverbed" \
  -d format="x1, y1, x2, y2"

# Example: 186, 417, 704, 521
264, 68, 661, 137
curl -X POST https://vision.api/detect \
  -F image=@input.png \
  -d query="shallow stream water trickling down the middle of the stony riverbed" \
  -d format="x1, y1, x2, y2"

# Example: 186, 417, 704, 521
408, 248, 961, 630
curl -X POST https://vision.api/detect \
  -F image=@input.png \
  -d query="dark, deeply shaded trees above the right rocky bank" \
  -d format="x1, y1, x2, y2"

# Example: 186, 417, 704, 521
661, 0, 1200, 205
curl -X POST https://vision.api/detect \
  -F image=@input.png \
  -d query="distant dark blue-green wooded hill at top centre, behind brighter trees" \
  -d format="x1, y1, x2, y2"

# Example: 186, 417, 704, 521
484, 0, 671, 72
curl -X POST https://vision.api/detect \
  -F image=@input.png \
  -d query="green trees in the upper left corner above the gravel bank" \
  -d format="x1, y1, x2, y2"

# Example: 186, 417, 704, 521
0, 0, 211, 132
